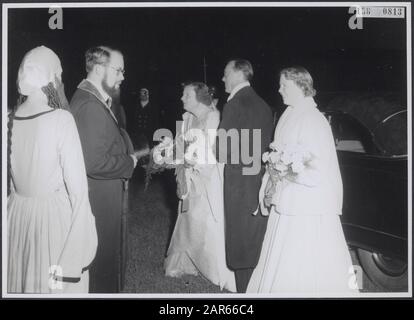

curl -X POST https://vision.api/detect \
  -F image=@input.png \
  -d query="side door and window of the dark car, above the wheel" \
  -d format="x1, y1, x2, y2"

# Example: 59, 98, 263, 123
328, 113, 408, 260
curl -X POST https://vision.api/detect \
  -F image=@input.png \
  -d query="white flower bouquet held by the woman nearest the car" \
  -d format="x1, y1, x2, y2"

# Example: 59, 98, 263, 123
262, 143, 312, 207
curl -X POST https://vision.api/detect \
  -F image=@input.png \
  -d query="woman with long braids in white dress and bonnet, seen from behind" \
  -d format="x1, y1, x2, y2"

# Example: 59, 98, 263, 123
7, 46, 97, 293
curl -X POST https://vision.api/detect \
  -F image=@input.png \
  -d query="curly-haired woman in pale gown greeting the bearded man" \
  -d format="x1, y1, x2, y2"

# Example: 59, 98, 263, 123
164, 82, 236, 291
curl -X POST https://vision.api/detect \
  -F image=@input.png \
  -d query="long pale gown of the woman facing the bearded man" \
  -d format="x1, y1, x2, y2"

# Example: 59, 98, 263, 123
164, 110, 236, 292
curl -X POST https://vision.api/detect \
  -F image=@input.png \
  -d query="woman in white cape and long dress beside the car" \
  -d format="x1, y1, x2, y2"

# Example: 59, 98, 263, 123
247, 67, 358, 296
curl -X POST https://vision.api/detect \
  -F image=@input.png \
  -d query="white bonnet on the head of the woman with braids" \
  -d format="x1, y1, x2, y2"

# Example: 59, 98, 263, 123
17, 46, 62, 96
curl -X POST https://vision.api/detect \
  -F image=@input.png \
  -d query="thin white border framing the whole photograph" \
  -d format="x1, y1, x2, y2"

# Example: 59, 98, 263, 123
1, 2, 412, 300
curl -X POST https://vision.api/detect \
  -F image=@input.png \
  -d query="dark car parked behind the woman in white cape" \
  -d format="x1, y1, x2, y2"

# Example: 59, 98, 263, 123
324, 110, 408, 291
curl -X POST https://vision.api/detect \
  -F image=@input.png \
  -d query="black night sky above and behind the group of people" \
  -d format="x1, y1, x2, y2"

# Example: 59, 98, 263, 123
8, 7, 407, 114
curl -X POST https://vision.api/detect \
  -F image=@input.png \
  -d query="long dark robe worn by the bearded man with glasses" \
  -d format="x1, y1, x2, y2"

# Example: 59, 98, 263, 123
70, 80, 134, 293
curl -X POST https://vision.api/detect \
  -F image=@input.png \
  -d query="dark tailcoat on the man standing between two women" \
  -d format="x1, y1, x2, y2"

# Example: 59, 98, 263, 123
217, 86, 273, 269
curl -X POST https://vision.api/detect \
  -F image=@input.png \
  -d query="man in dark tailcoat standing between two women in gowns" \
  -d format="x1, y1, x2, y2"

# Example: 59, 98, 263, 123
217, 60, 273, 292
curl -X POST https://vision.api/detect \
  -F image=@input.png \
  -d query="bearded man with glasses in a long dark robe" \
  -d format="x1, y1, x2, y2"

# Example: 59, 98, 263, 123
70, 47, 146, 293
